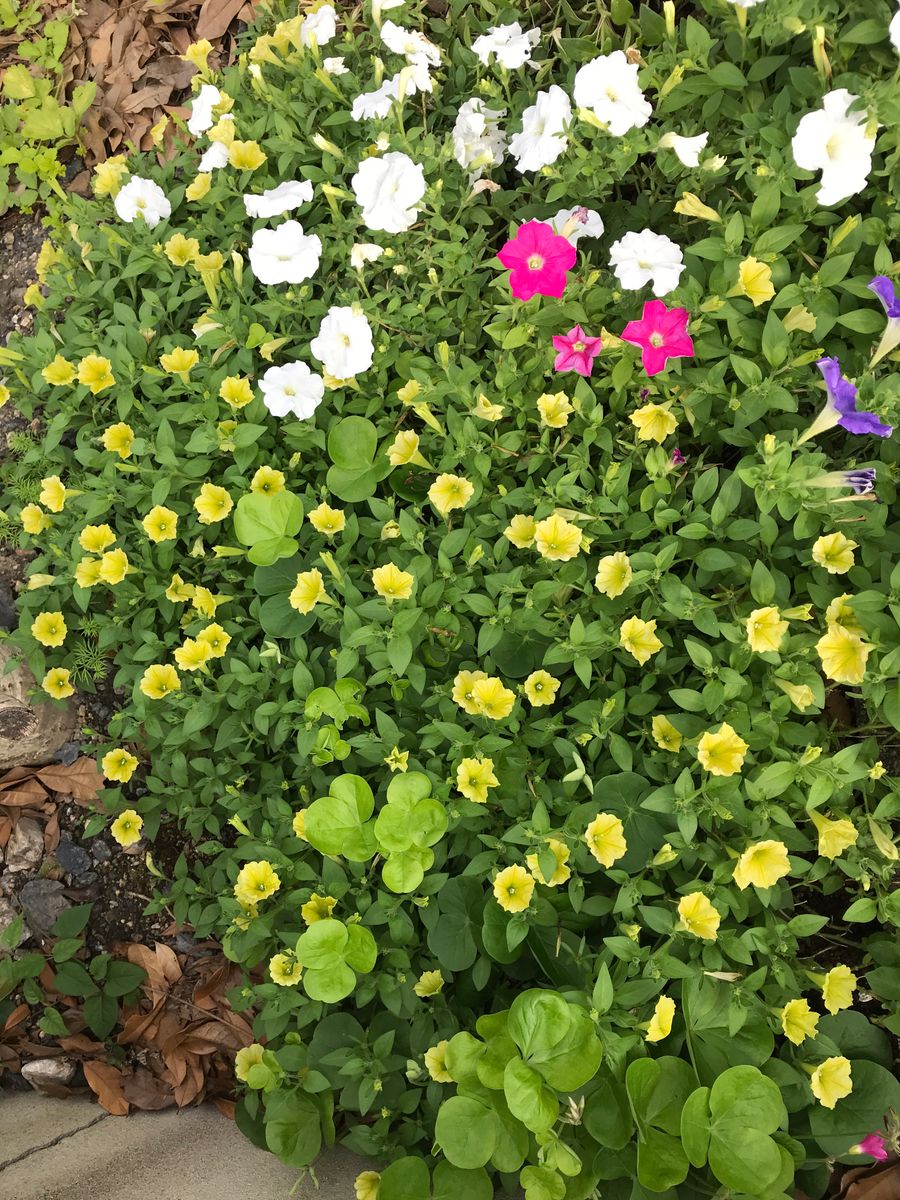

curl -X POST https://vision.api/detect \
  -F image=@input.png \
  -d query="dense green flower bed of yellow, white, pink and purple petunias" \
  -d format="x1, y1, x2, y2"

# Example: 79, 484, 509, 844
2, 0, 900, 1200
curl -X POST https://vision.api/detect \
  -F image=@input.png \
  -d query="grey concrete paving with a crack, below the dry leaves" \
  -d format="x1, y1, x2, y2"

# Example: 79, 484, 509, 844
0, 1092, 368, 1200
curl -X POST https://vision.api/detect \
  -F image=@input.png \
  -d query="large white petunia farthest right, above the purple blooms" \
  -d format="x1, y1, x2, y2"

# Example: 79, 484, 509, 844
791, 88, 875, 208
